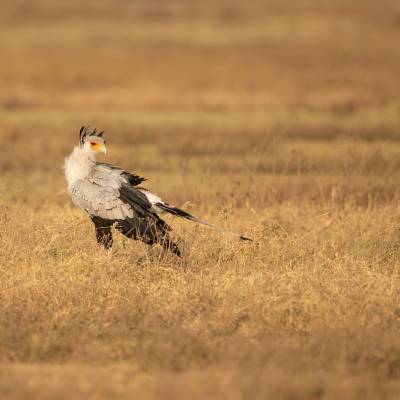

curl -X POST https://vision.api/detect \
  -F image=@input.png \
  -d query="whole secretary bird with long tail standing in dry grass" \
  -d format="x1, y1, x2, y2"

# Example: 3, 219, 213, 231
64, 126, 251, 257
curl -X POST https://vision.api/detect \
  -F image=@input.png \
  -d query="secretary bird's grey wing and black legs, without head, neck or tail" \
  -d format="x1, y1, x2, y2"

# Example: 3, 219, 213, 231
70, 163, 180, 255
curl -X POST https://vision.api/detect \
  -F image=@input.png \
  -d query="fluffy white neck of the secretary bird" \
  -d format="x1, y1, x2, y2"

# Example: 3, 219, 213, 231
64, 146, 95, 188
